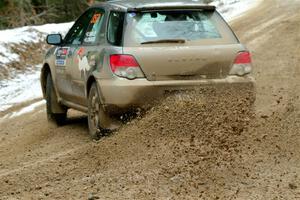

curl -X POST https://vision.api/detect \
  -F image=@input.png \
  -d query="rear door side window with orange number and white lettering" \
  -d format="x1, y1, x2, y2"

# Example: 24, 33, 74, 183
83, 10, 104, 44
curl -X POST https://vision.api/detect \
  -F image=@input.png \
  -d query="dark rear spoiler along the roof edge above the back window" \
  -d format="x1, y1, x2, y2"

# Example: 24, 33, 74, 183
127, 4, 216, 12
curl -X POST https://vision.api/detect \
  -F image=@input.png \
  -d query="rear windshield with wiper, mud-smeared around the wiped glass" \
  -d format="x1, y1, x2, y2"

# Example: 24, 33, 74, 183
125, 10, 236, 45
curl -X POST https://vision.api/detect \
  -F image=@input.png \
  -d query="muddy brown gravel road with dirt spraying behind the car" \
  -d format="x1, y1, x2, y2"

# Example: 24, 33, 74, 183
0, 0, 300, 200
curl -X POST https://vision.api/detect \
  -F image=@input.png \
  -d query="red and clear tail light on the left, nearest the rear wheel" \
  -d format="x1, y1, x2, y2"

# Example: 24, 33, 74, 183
110, 54, 145, 80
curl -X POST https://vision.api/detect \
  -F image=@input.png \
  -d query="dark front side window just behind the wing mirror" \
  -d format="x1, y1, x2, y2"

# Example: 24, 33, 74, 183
64, 10, 94, 44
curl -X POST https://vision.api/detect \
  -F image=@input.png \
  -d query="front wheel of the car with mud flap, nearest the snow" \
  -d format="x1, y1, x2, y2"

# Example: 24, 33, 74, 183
46, 73, 67, 126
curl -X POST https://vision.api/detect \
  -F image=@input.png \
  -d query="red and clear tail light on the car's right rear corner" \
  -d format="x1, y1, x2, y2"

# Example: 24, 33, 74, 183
230, 51, 252, 76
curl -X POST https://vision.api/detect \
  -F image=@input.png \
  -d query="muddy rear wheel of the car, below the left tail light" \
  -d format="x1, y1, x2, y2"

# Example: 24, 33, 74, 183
88, 83, 104, 140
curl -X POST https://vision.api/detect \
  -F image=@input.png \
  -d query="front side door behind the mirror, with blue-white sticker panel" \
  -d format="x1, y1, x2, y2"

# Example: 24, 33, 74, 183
55, 9, 94, 102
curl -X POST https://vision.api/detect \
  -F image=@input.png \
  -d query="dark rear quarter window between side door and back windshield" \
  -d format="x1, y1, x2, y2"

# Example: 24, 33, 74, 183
107, 12, 125, 46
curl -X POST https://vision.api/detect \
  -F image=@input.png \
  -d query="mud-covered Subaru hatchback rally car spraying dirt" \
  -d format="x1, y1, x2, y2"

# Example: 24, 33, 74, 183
41, 0, 253, 139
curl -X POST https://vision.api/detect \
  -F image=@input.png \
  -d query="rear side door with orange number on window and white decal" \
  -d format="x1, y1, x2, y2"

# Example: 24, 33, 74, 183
70, 8, 105, 106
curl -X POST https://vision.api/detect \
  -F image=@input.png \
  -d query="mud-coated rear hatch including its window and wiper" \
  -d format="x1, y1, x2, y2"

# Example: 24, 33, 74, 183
123, 7, 244, 81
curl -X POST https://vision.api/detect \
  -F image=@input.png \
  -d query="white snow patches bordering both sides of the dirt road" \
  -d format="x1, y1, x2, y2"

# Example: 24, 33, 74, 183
0, 0, 260, 118
